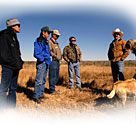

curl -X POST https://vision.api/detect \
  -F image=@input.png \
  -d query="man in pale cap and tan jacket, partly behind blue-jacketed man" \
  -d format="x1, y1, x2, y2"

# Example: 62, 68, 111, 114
48, 30, 62, 94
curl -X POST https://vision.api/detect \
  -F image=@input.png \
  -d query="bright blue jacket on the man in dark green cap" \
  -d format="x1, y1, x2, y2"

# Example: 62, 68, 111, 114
34, 40, 51, 64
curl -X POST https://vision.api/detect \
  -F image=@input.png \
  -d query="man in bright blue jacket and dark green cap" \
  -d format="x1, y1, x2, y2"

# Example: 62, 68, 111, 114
34, 26, 52, 104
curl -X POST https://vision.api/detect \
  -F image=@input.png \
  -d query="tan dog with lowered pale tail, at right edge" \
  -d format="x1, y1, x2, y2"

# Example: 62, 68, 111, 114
107, 79, 136, 105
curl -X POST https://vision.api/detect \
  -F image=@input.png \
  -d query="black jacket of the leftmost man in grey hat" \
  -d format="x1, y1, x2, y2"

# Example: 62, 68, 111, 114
0, 29, 24, 70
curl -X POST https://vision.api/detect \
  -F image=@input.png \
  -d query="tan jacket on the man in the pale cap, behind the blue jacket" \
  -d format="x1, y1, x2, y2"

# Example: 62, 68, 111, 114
48, 40, 62, 61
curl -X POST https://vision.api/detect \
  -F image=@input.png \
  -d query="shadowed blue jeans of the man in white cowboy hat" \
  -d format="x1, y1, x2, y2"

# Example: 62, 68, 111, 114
111, 61, 125, 82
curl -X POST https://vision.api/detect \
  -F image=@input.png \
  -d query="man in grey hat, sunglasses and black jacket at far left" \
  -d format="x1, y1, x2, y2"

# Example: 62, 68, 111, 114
0, 18, 23, 107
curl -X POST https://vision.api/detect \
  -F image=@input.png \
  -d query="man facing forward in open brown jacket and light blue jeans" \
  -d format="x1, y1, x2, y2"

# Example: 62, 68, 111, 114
63, 36, 81, 90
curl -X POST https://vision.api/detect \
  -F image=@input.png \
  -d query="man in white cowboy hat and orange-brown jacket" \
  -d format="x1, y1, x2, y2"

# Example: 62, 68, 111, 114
108, 28, 129, 82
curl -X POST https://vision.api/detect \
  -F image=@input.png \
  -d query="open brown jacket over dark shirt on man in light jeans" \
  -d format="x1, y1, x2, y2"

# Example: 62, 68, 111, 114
63, 45, 82, 62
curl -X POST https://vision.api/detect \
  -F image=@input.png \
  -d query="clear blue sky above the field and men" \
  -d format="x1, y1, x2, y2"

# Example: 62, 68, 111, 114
0, 0, 135, 61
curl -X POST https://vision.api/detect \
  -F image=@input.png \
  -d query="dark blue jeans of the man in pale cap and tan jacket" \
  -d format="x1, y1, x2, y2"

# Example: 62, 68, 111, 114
49, 61, 60, 93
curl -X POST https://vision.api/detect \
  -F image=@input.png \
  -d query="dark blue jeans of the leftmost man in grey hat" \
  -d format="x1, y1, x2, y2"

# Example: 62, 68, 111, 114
0, 66, 19, 108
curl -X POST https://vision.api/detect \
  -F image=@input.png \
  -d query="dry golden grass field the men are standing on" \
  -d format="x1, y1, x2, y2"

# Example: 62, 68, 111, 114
0, 62, 135, 113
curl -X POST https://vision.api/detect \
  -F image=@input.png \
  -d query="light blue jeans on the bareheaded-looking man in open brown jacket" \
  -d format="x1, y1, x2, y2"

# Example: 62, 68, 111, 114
68, 62, 81, 88
